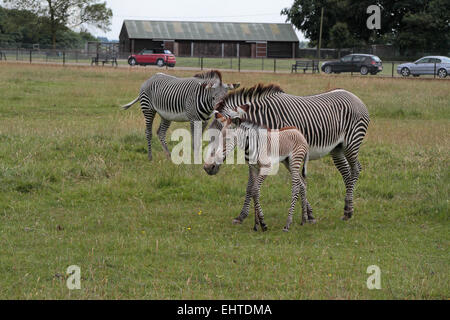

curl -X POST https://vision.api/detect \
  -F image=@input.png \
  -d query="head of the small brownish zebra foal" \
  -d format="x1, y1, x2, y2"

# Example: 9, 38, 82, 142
203, 107, 243, 175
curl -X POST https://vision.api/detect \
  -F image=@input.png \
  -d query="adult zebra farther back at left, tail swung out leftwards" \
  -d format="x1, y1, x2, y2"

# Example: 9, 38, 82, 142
122, 70, 239, 160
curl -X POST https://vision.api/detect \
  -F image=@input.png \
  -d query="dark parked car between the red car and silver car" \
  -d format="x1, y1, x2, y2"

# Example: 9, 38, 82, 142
322, 53, 383, 75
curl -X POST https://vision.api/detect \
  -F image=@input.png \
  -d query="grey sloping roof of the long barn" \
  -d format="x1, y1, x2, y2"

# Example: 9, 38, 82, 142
122, 20, 298, 42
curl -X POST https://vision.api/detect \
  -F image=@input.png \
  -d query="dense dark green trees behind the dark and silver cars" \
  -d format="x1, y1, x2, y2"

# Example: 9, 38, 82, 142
281, 0, 450, 56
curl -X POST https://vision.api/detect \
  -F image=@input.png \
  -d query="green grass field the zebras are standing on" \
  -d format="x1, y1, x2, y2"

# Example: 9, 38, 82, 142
0, 63, 450, 299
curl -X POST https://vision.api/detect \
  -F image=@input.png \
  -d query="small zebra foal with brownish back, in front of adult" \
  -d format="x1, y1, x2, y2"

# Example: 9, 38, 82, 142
204, 108, 308, 231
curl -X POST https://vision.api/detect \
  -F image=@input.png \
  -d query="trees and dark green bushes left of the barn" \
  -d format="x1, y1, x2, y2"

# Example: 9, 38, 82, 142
0, 0, 112, 48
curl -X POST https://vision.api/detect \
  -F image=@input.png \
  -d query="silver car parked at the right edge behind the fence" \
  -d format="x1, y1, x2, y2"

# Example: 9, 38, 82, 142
397, 56, 450, 78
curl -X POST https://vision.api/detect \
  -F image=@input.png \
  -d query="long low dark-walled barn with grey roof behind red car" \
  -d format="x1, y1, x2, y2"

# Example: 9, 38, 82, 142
119, 20, 299, 58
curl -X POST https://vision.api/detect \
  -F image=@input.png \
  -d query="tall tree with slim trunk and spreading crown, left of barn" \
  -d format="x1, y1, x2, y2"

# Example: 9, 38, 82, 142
3, 0, 112, 48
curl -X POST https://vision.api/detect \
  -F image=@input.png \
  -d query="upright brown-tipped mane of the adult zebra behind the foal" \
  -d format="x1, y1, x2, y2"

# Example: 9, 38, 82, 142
215, 83, 284, 112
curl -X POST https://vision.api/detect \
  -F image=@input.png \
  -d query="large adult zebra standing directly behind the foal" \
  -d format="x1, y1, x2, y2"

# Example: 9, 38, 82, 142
209, 84, 370, 222
